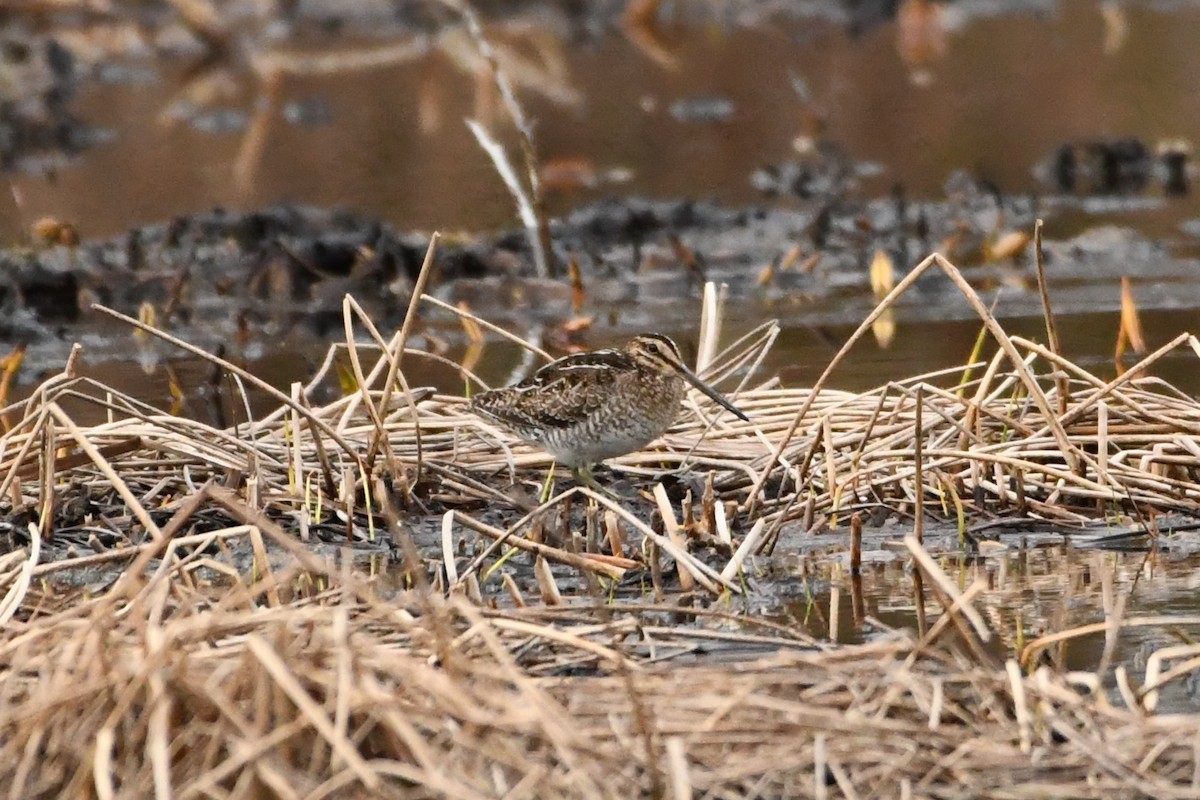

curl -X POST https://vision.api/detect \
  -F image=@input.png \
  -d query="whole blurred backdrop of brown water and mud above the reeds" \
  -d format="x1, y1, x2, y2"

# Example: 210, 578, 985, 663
0, 0, 1200, 401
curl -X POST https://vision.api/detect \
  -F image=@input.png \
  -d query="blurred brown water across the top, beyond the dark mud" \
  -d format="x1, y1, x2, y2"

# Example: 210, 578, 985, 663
9, 0, 1200, 239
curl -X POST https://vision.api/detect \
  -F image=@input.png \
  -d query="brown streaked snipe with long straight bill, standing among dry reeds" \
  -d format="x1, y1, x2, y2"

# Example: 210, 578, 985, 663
469, 333, 750, 491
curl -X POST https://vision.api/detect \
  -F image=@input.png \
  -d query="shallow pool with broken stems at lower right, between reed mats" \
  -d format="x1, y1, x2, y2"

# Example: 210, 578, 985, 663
762, 543, 1200, 711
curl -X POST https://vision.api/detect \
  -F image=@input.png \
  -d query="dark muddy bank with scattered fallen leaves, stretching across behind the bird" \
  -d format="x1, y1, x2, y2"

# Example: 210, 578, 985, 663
9, 182, 1200, 381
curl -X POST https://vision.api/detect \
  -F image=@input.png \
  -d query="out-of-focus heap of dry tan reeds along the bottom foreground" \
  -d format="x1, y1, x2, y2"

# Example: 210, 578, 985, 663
0, 570, 1200, 798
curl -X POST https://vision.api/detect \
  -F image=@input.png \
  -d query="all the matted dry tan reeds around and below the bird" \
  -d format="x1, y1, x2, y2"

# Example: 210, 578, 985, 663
0, 251, 1200, 798
